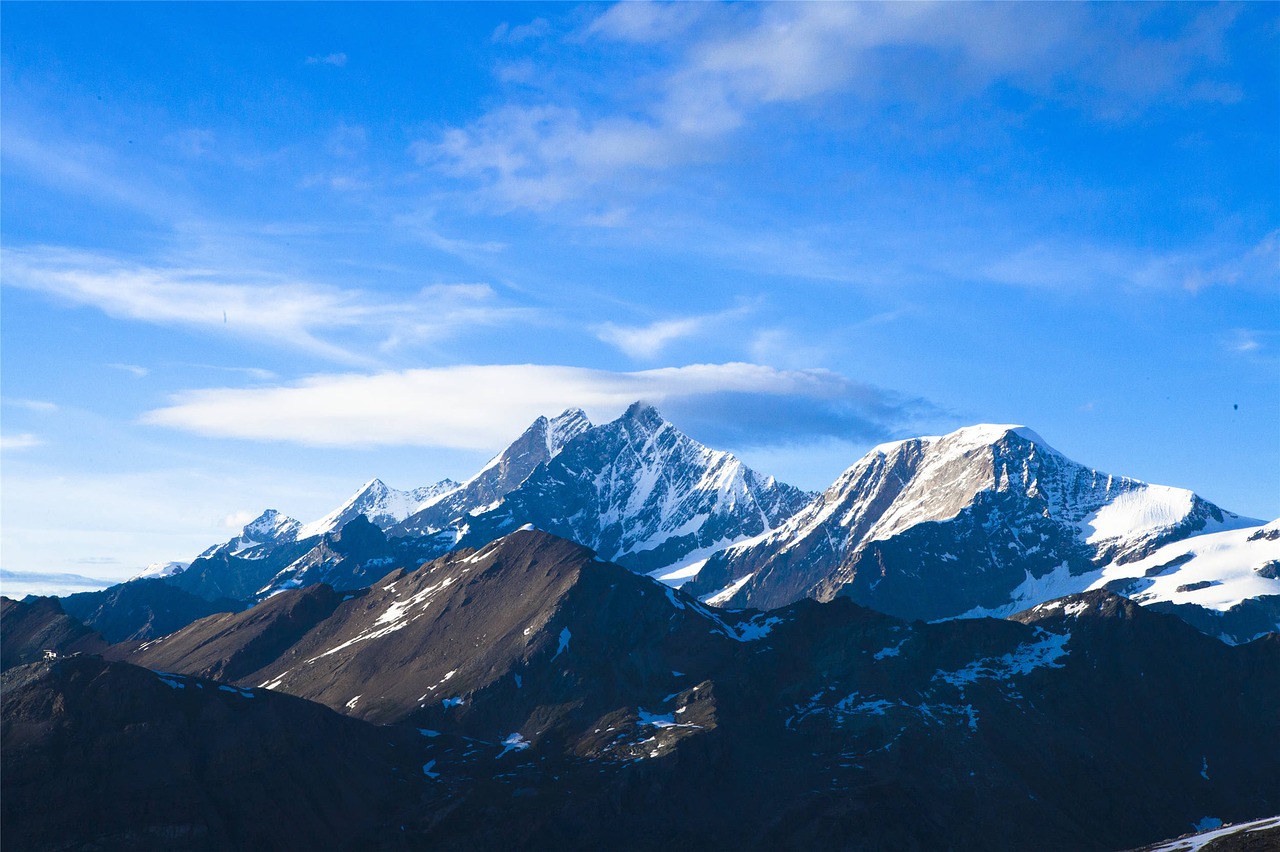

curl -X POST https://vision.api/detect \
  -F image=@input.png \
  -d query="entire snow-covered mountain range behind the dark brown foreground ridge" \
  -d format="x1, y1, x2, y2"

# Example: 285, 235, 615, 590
45, 403, 1280, 642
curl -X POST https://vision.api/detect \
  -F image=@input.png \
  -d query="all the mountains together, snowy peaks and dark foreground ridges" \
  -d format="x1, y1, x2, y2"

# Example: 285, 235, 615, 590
0, 403, 1280, 851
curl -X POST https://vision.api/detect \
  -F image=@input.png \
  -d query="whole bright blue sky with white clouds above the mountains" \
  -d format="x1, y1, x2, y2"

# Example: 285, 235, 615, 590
0, 4, 1280, 588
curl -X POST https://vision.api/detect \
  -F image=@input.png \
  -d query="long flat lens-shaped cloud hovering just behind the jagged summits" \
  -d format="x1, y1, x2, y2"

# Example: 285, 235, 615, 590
142, 363, 932, 449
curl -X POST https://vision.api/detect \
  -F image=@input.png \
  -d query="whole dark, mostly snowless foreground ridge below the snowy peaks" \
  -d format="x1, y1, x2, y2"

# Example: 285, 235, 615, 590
3, 531, 1280, 851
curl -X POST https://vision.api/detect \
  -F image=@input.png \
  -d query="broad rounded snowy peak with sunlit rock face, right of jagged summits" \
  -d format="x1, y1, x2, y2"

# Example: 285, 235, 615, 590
689, 426, 1249, 619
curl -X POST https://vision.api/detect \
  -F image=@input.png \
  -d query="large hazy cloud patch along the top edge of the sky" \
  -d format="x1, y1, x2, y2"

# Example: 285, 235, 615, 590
424, 4, 1240, 210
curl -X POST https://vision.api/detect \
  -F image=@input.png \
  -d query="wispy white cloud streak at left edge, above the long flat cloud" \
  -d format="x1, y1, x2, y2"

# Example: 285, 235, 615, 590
4, 248, 531, 368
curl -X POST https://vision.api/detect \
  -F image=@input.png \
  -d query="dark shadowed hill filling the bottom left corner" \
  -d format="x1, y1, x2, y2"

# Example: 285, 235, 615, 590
0, 656, 425, 849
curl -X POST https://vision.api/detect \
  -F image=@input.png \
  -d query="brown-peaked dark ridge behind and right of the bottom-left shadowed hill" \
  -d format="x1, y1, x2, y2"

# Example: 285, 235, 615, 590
112, 531, 1280, 851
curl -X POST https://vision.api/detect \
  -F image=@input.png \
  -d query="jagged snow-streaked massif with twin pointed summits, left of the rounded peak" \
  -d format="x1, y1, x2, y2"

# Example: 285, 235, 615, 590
182, 403, 812, 600
